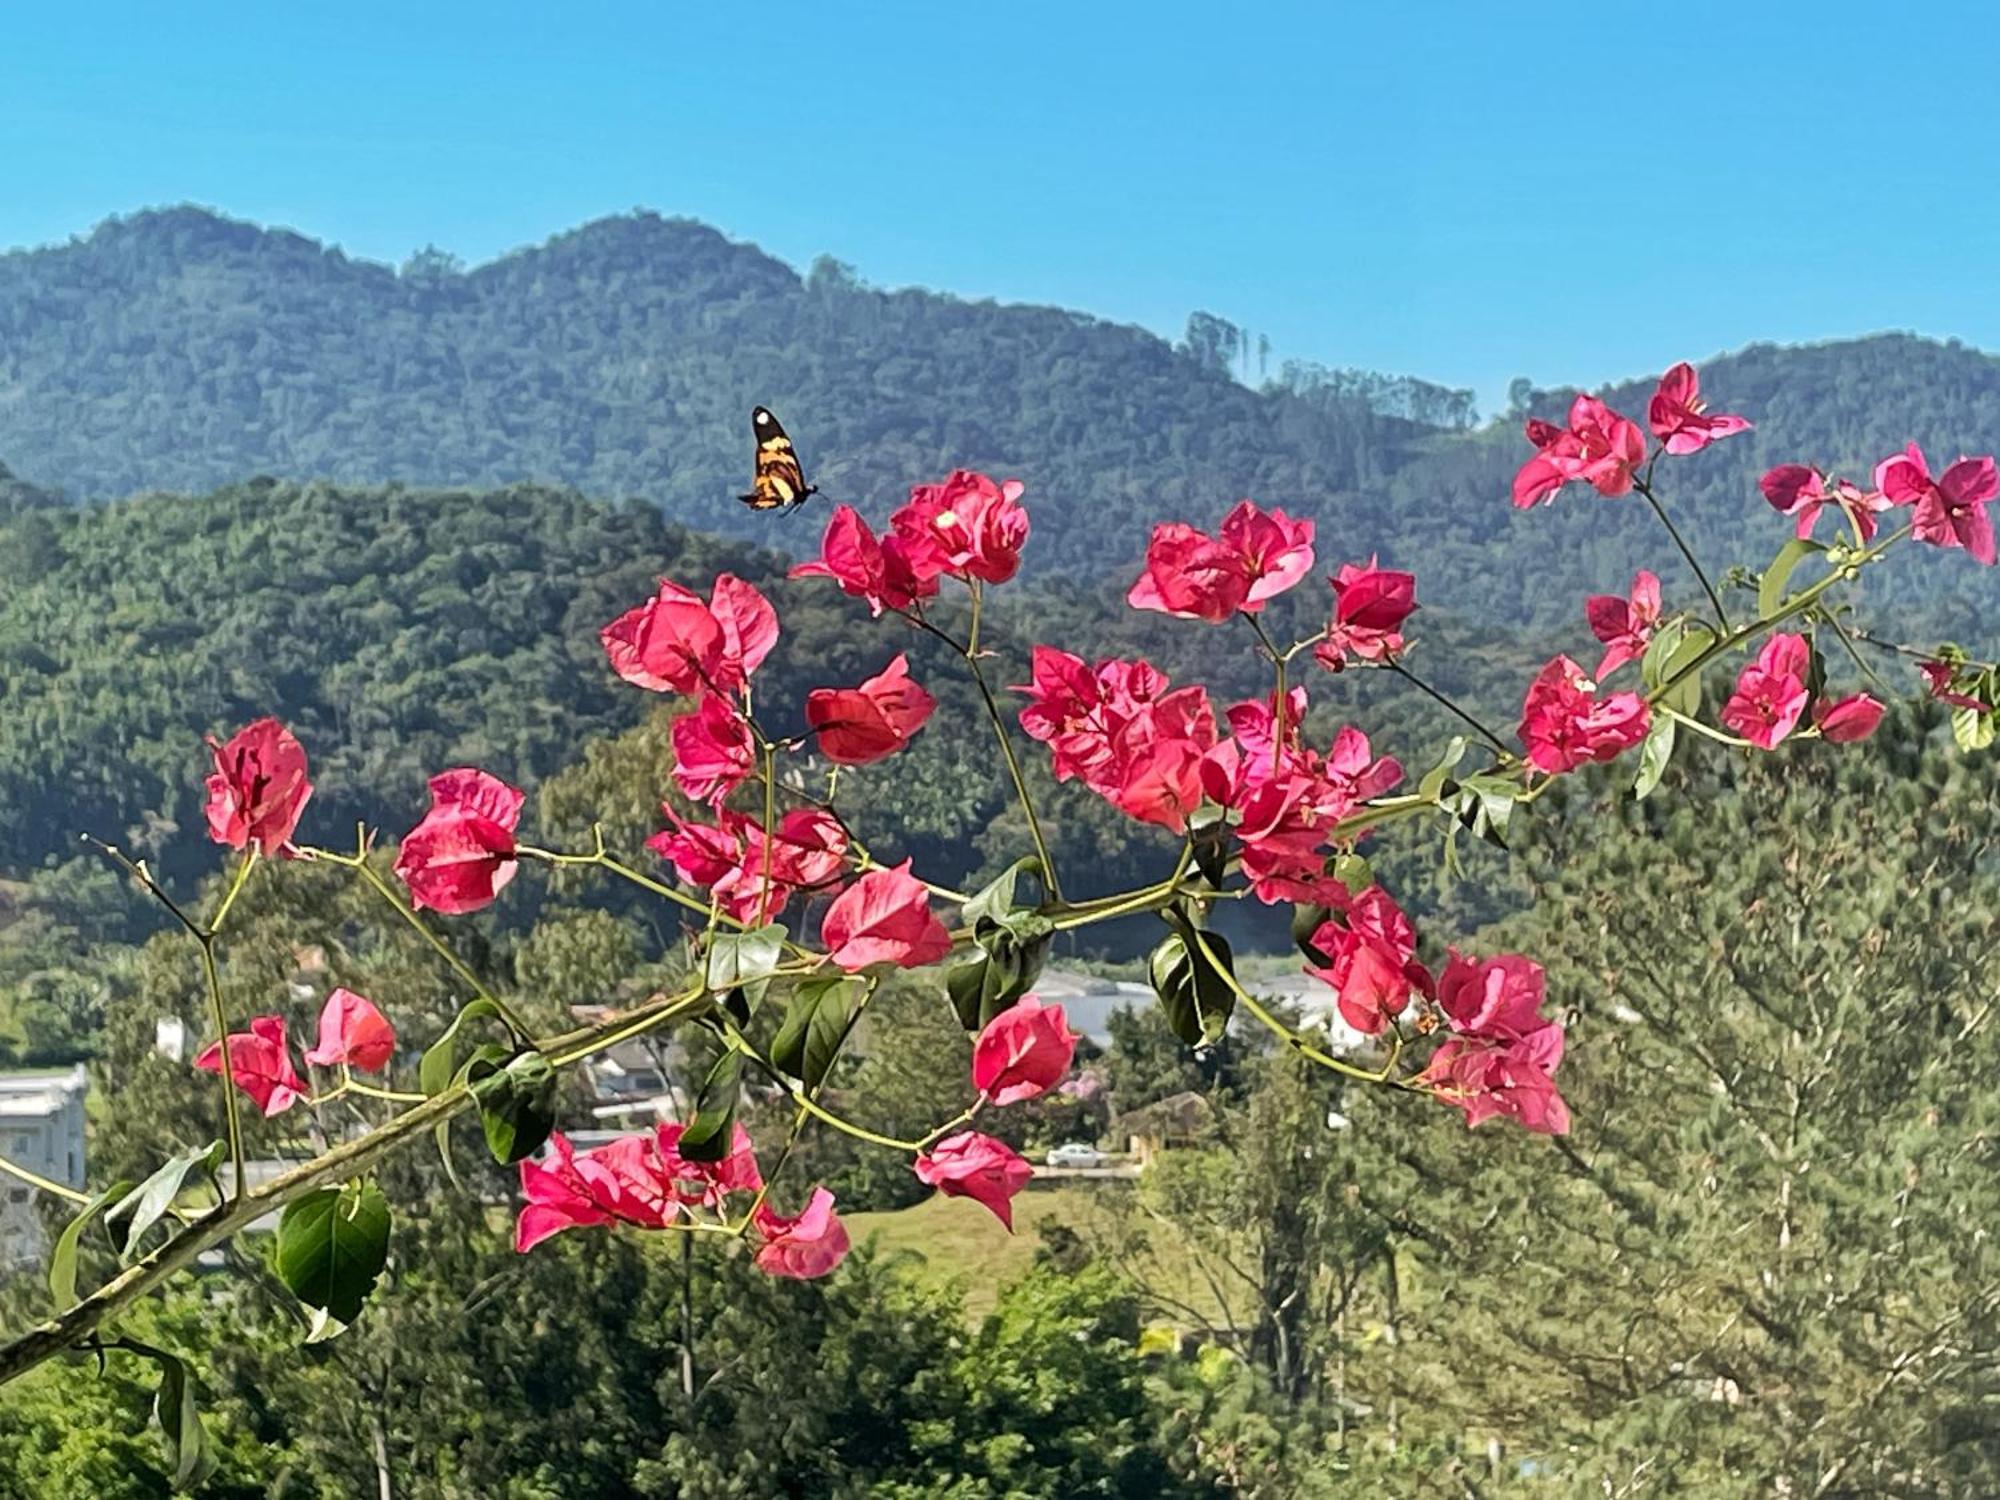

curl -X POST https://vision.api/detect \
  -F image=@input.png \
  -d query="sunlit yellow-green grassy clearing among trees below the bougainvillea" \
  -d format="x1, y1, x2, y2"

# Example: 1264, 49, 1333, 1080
846, 1182, 1222, 1328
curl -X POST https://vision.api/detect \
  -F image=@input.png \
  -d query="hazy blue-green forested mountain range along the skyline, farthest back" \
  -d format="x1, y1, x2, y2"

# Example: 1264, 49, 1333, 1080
11, 208, 2000, 628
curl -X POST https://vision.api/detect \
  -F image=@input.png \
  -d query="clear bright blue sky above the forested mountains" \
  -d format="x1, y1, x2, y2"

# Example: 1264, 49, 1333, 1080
0, 0, 2000, 408
